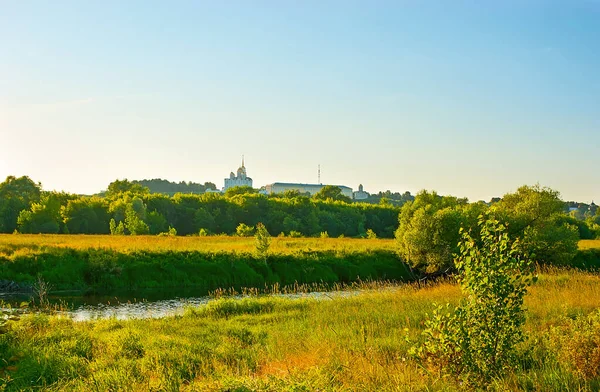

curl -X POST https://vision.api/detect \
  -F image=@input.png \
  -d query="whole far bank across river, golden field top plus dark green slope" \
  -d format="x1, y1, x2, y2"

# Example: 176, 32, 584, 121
0, 235, 411, 293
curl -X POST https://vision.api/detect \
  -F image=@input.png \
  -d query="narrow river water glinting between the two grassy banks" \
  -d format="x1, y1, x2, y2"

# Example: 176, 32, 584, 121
0, 291, 358, 321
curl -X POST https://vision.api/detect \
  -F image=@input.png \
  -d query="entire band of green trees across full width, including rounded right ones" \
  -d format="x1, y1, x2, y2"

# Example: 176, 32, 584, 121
0, 176, 600, 258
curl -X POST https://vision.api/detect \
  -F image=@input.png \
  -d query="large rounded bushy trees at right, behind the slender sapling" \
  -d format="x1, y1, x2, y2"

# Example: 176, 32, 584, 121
396, 185, 600, 273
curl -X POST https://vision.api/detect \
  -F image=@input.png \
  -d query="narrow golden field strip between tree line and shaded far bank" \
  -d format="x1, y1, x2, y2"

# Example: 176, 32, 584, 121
0, 234, 395, 256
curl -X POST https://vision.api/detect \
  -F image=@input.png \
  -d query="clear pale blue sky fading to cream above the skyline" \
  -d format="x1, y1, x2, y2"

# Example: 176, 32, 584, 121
0, 0, 600, 202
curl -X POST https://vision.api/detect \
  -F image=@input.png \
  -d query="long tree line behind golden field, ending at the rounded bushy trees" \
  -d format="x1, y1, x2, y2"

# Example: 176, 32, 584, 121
0, 176, 399, 238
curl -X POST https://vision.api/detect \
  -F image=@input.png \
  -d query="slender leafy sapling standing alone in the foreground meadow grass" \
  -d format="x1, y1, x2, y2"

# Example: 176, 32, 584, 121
412, 215, 535, 387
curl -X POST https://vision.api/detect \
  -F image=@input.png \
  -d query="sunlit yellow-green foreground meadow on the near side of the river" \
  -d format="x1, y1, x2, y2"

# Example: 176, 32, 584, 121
0, 271, 600, 391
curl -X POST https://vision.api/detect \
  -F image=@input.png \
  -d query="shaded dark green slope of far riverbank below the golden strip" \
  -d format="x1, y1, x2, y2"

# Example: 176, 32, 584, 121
0, 240, 412, 294
